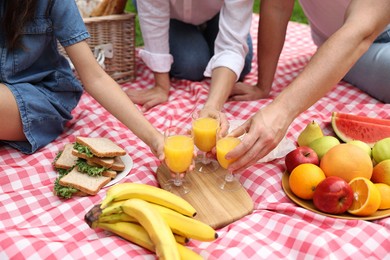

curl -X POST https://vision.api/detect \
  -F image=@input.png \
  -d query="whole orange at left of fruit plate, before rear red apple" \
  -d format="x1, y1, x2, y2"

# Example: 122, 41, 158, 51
288, 163, 326, 200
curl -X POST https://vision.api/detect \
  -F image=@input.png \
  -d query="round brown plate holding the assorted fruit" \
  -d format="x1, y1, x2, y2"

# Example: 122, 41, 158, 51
282, 172, 390, 220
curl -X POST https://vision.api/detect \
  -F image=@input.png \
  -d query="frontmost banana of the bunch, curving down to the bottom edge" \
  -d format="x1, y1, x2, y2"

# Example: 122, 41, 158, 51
121, 199, 180, 260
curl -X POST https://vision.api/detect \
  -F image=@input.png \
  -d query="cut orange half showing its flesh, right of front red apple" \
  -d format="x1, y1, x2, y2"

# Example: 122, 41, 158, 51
348, 177, 381, 216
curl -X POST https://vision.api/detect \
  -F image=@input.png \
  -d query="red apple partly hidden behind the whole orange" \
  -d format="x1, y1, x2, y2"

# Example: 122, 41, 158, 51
284, 146, 319, 173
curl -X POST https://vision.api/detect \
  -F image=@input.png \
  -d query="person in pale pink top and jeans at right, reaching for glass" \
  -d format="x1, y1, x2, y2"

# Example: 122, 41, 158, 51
227, 0, 390, 171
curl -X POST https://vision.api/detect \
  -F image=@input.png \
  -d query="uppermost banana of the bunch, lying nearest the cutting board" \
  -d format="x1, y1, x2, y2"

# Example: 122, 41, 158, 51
101, 182, 196, 217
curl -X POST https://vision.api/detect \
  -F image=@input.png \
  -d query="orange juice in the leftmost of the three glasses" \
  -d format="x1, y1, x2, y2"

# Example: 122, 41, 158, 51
164, 135, 194, 173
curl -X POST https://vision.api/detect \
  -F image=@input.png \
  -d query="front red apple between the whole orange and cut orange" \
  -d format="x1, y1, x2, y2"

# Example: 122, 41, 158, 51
313, 176, 353, 214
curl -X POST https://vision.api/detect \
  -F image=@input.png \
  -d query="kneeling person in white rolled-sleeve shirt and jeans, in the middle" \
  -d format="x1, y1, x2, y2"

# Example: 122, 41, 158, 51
127, 0, 253, 111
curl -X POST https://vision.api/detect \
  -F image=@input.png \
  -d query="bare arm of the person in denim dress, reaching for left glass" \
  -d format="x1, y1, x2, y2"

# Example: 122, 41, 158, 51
65, 41, 163, 156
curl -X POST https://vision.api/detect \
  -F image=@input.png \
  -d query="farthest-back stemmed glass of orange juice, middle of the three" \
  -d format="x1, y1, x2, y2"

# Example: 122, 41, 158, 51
192, 109, 220, 173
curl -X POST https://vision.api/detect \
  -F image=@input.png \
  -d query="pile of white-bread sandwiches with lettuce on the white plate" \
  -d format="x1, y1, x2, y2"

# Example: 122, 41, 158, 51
53, 137, 127, 199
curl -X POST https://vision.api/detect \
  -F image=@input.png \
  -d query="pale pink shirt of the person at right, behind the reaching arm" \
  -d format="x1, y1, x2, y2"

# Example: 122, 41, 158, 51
299, 0, 390, 45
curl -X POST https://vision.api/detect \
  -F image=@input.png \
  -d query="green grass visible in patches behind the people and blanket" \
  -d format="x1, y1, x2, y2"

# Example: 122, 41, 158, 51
126, 0, 307, 46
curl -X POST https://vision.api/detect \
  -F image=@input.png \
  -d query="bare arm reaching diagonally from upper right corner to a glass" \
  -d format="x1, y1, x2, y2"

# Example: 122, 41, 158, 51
228, 0, 390, 173
